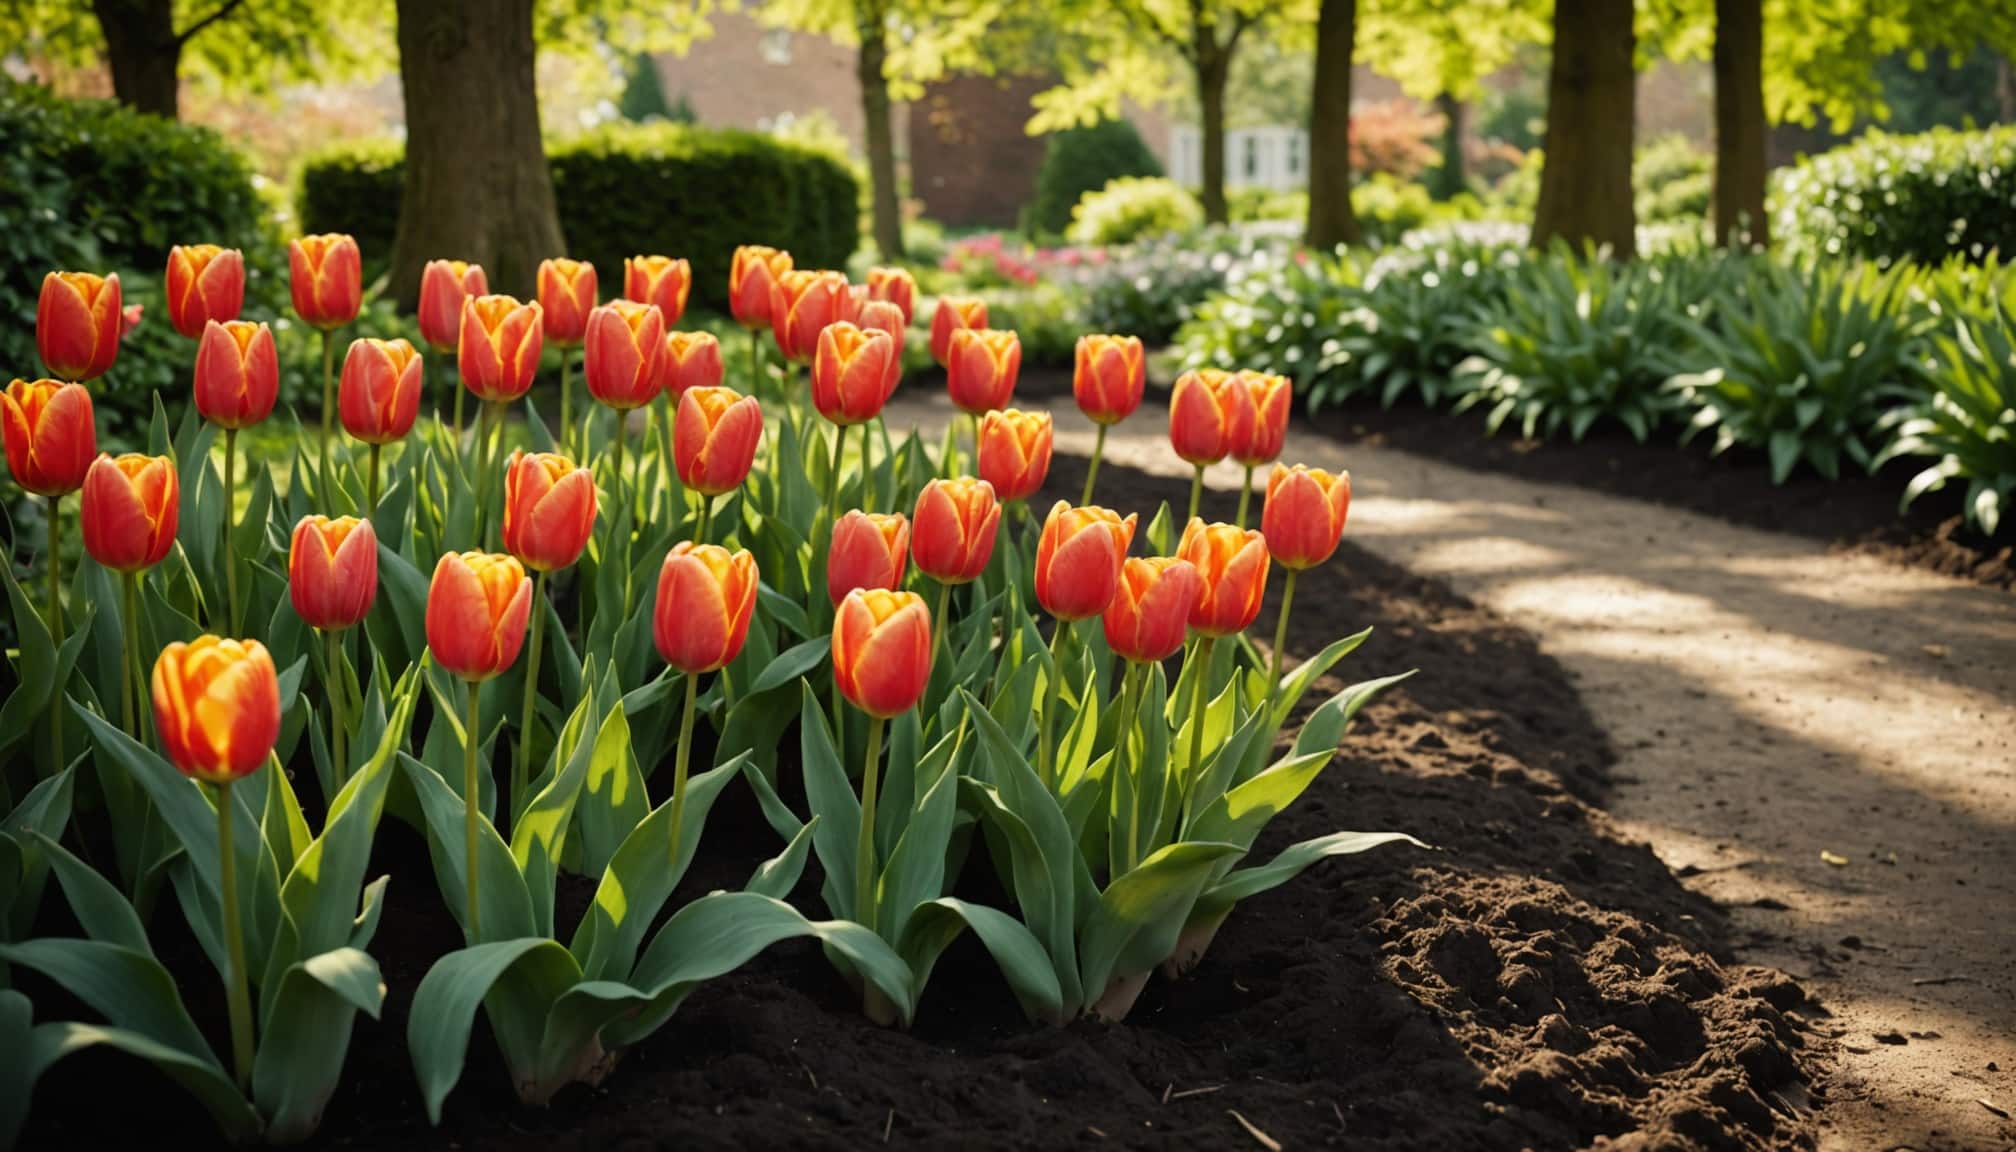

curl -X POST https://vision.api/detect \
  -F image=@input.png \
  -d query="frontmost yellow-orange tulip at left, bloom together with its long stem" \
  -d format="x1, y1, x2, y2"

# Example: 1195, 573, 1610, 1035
153, 636, 280, 1089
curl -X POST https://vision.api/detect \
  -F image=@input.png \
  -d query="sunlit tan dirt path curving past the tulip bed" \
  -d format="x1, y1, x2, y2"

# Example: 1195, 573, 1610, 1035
889, 397, 2016, 1150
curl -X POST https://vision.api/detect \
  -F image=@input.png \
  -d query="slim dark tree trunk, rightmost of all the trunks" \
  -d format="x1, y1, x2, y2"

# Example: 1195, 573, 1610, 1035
1716, 0, 1768, 246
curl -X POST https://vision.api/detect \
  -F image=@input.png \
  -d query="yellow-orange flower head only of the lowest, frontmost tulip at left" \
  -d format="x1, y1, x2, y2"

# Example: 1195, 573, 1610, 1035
153, 636, 280, 785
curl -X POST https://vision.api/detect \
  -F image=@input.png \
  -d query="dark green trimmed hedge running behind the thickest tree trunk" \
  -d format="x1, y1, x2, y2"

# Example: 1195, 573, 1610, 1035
296, 123, 861, 309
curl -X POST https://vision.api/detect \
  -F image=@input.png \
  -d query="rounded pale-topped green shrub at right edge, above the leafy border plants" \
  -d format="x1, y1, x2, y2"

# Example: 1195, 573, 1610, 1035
1772, 127, 2016, 266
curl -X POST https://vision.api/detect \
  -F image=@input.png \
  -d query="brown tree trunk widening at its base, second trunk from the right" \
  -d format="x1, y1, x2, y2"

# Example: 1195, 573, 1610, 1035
1532, 0, 1637, 260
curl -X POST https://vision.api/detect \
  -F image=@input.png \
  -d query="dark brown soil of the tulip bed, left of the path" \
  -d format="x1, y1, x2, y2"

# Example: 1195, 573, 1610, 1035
24, 458, 1818, 1152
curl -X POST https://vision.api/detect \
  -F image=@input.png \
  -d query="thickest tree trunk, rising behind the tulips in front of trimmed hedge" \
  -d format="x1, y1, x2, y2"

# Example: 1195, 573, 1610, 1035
391, 0, 566, 311
